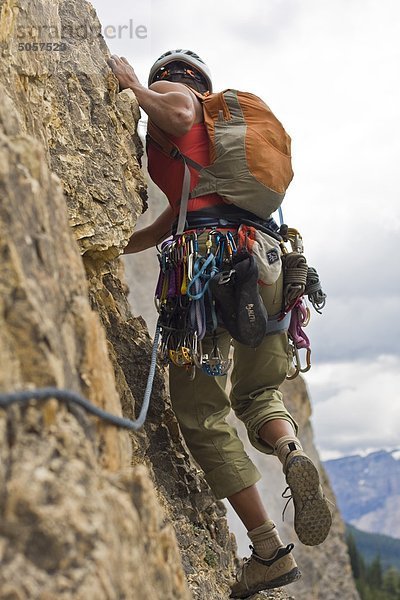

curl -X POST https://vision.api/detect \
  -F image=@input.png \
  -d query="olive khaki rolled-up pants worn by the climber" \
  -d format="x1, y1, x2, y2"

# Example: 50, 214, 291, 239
170, 264, 298, 498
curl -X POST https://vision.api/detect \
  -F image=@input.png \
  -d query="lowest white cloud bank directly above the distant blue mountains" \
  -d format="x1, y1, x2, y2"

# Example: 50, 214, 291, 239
307, 355, 400, 459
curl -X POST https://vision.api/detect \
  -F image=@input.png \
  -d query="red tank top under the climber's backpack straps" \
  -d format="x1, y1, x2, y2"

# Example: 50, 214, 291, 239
147, 123, 225, 214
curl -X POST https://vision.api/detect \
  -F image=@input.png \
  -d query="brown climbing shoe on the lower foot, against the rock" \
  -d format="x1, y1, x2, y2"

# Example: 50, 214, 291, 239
231, 544, 301, 598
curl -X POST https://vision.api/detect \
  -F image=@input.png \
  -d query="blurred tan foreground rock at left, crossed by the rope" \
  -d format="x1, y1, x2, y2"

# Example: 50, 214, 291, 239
0, 110, 190, 599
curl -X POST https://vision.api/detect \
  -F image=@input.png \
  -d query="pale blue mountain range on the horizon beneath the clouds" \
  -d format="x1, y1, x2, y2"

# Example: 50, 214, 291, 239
324, 450, 400, 538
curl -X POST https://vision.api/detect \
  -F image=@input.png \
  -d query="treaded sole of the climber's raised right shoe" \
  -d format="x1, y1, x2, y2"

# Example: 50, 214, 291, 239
286, 456, 332, 546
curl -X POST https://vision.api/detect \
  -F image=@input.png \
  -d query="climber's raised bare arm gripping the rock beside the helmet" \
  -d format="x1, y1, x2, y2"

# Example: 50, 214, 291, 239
108, 54, 196, 137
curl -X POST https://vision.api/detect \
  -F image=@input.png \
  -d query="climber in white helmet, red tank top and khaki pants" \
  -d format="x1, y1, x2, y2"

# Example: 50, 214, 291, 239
108, 50, 331, 598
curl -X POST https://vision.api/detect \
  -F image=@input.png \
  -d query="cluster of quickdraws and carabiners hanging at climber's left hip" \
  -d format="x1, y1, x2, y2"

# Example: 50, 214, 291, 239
155, 229, 237, 378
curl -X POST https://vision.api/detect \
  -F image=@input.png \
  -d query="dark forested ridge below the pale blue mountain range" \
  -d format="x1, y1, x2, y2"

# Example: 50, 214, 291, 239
346, 524, 400, 571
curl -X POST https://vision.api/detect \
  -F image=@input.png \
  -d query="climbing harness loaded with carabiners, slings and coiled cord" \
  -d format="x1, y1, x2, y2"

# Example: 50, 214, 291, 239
155, 215, 326, 379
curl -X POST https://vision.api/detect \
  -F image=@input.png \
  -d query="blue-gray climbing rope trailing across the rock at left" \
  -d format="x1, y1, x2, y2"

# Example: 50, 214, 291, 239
0, 323, 160, 431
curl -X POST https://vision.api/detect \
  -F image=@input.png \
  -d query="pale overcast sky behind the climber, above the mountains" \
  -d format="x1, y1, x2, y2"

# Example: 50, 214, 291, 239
88, 0, 400, 459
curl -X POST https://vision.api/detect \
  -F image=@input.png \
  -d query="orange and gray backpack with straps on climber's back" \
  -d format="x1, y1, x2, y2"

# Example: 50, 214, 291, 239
148, 88, 293, 234
